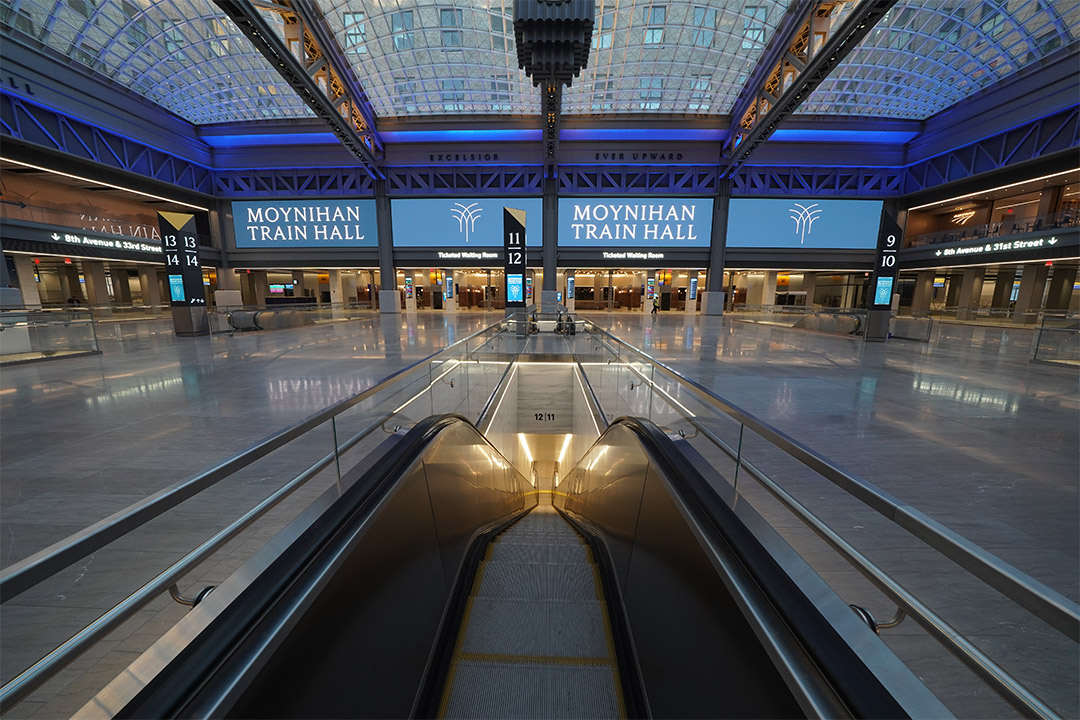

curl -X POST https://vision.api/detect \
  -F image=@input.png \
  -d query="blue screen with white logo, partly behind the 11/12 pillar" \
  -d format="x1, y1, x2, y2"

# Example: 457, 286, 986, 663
390, 196, 543, 249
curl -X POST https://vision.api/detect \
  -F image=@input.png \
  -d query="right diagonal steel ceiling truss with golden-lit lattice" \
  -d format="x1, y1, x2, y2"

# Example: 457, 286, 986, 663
720, 0, 896, 177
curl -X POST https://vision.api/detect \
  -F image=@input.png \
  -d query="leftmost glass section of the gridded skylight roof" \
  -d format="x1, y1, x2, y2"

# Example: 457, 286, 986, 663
0, 0, 311, 124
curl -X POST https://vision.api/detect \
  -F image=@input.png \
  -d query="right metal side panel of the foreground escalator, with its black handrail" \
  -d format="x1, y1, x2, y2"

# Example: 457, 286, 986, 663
564, 419, 947, 717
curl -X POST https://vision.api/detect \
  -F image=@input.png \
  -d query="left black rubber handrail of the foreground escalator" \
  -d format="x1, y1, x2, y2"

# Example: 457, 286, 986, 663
107, 413, 531, 718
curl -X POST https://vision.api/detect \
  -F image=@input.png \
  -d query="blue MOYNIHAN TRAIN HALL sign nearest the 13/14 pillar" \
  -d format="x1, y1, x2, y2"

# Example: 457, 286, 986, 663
232, 200, 379, 249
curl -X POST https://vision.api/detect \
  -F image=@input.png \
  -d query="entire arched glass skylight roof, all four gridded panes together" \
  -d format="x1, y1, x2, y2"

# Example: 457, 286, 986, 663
0, 0, 1080, 124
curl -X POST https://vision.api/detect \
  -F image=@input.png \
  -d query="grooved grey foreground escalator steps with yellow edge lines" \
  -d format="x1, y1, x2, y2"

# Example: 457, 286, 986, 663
438, 504, 624, 718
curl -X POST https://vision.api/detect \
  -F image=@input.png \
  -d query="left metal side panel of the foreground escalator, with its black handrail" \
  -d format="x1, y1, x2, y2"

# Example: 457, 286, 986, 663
84, 416, 528, 718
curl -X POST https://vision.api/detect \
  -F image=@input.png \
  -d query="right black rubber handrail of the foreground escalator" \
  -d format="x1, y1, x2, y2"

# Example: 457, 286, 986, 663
586, 417, 907, 718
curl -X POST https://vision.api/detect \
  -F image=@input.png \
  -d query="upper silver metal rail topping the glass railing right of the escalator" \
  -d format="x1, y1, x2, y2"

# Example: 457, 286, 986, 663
585, 320, 1080, 641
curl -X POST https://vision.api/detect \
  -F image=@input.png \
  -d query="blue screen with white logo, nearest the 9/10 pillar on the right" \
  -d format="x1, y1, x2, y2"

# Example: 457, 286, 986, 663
727, 198, 881, 249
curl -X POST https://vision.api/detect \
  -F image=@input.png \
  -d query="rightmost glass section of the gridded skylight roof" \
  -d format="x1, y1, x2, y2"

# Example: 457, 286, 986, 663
797, 0, 1080, 120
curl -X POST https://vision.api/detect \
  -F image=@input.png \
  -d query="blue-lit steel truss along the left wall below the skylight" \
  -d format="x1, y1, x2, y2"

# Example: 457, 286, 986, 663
0, 93, 214, 194
